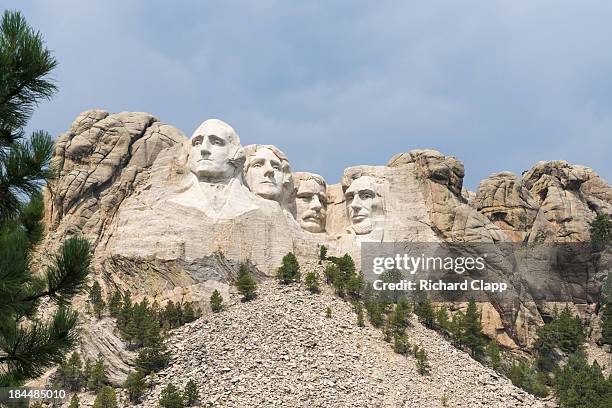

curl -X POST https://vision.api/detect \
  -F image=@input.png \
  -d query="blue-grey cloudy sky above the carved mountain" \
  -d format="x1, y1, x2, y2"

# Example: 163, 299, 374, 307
2, 0, 612, 190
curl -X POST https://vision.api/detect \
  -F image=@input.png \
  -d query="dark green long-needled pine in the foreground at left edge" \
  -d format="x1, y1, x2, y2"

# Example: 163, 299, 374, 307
0, 10, 90, 387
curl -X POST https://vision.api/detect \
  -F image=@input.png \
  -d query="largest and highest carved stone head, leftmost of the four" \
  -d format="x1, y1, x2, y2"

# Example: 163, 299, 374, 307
189, 119, 245, 183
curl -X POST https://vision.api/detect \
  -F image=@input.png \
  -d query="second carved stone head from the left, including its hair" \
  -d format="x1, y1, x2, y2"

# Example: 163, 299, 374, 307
244, 145, 291, 203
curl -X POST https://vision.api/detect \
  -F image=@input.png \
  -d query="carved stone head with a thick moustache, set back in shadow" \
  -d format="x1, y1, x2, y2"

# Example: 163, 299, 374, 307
293, 173, 327, 232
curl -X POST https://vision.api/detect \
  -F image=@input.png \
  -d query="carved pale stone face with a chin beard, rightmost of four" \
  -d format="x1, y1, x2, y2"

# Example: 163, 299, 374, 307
344, 176, 384, 235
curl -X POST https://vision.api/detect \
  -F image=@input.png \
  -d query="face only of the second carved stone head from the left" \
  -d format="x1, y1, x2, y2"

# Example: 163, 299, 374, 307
245, 146, 285, 202
